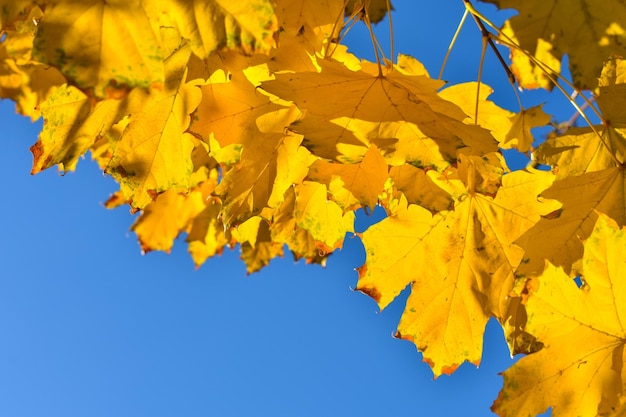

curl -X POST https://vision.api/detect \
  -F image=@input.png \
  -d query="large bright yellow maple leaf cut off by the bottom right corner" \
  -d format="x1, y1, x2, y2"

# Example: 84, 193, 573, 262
492, 214, 626, 417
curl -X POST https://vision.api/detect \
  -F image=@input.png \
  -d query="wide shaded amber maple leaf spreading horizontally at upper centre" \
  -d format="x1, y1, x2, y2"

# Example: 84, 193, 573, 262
262, 60, 496, 164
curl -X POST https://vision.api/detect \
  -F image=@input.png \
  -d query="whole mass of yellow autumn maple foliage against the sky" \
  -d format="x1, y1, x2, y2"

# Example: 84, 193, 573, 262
0, 0, 626, 416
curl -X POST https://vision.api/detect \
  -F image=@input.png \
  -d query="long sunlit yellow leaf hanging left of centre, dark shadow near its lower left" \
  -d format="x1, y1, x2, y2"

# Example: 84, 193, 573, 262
107, 48, 201, 209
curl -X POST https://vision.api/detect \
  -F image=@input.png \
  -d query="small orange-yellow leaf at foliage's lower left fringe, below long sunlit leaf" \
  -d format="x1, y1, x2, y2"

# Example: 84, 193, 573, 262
131, 190, 205, 253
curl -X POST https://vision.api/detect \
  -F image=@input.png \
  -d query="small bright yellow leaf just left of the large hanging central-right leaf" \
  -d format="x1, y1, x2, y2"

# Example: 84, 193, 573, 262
294, 181, 354, 252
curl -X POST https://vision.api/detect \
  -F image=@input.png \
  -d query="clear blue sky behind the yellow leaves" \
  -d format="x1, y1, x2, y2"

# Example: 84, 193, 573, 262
0, 0, 564, 417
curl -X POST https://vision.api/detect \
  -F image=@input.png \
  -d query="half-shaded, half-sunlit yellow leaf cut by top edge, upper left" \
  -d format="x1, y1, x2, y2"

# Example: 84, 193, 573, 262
33, 0, 164, 97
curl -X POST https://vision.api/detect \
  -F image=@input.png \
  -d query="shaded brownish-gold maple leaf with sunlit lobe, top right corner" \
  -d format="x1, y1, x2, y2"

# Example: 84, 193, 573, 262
485, 0, 626, 89
